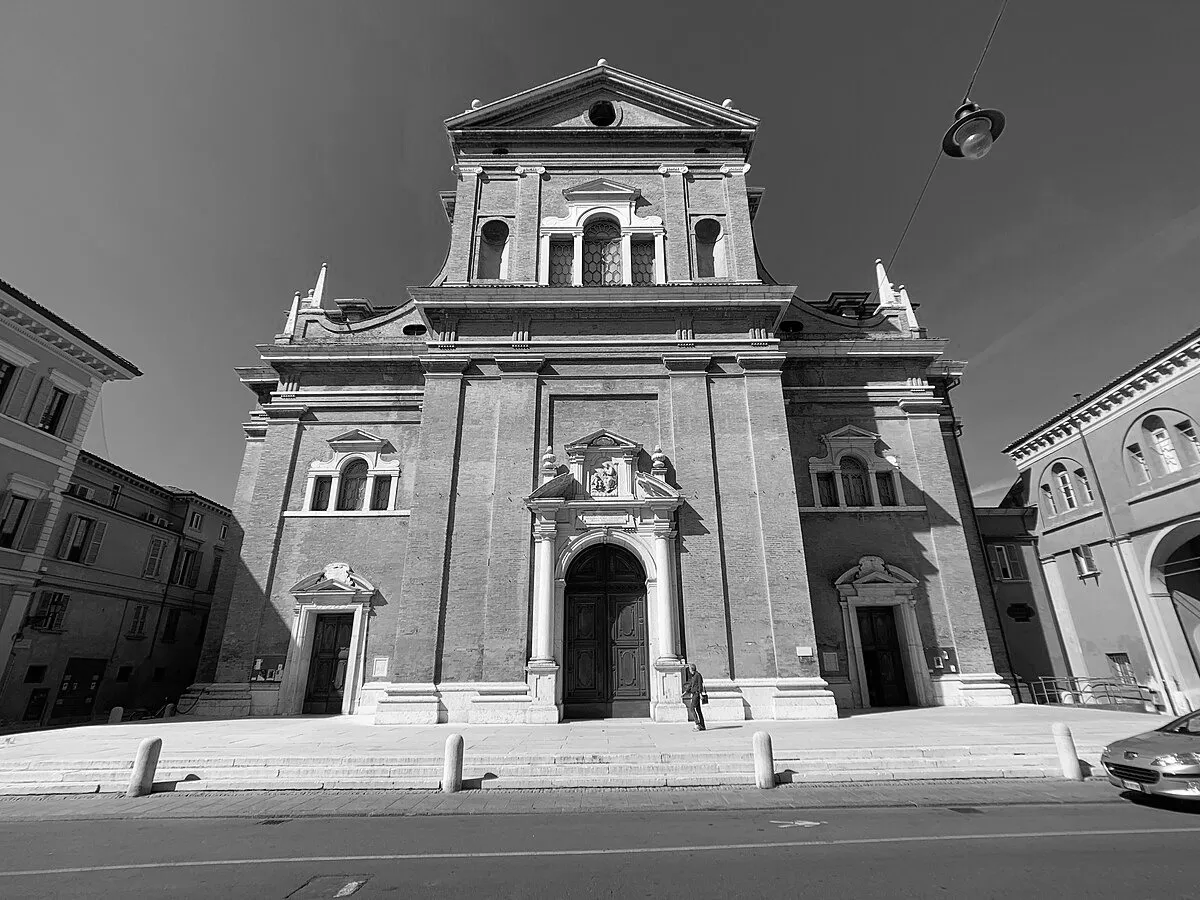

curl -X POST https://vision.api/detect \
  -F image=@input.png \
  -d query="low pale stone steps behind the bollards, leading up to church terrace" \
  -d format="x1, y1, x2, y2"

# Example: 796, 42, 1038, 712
0, 743, 1100, 794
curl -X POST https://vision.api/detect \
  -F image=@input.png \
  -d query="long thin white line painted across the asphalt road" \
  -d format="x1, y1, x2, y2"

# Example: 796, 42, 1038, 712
0, 828, 1200, 878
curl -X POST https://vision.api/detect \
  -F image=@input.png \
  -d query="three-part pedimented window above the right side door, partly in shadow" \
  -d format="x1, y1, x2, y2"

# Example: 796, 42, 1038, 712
809, 425, 904, 509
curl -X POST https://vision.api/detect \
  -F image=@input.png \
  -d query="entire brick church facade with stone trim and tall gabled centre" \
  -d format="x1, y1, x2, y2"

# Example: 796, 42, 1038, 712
187, 60, 1013, 724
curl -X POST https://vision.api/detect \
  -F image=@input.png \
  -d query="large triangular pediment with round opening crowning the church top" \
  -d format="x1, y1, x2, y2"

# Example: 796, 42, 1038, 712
446, 64, 758, 131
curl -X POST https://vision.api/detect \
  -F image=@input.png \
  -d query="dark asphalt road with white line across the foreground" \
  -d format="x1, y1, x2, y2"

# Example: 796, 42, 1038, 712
0, 803, 1200, 900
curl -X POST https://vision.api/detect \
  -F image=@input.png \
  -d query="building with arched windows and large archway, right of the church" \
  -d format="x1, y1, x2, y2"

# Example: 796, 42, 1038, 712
1004, 330, 1200, 713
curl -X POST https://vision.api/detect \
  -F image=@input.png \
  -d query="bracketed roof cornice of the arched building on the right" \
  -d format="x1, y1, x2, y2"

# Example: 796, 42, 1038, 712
1004, 330, 1200, 467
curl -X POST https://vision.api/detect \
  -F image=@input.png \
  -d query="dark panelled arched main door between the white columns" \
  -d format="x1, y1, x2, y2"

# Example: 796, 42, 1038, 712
563, 544, 650, 719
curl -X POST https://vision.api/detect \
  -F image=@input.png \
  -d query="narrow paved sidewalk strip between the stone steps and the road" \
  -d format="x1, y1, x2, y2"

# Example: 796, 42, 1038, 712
0, 779, 1126, 826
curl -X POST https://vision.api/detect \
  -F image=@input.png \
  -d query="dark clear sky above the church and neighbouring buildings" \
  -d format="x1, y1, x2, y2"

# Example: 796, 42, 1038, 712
0, 0, 1200, 502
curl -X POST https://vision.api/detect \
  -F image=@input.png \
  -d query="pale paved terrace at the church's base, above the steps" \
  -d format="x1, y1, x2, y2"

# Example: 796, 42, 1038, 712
0, 704, 1166, 764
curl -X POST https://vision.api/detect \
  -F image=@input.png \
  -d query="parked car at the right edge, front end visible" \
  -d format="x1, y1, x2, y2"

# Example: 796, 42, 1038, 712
1100, 712, 1200, 800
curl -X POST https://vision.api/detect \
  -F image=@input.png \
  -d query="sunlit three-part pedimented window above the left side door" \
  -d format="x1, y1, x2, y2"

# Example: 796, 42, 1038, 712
298, 430, 400, 516
